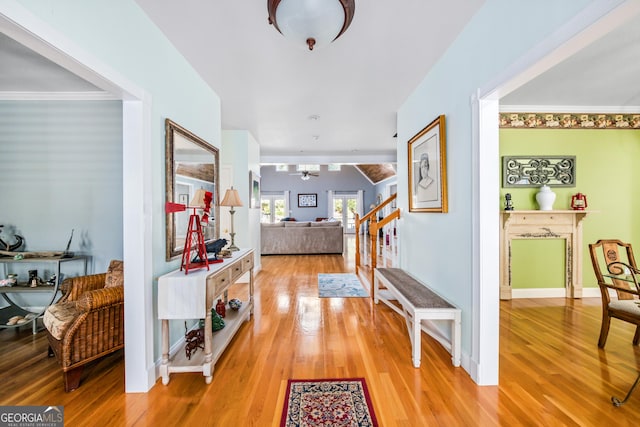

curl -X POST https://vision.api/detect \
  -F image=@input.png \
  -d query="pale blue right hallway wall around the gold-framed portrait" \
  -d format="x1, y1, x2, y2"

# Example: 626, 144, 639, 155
397, 0, 590, 362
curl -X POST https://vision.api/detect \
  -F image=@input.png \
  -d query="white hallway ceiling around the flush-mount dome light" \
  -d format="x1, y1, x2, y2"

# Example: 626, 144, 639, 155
136, 0, 483, 159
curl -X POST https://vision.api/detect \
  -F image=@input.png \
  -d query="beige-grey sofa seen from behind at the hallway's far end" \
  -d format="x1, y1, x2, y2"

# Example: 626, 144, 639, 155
260, 221, 344, 255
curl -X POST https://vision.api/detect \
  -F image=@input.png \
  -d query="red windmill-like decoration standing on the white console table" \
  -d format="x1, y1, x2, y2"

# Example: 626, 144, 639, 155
165, 188, 213, 274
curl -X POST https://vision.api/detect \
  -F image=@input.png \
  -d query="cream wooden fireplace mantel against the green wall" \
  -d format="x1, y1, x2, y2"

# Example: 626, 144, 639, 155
500, 210, 589, 300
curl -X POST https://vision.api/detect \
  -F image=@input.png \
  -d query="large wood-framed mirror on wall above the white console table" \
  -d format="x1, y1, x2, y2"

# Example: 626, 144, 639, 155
165, 119, 220, 261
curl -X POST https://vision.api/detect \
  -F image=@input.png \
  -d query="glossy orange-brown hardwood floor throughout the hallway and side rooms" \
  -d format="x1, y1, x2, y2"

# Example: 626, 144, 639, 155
0, 242, 640, 427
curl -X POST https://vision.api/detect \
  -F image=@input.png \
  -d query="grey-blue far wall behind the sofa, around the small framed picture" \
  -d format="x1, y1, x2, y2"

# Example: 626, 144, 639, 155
261, 165, 376, 221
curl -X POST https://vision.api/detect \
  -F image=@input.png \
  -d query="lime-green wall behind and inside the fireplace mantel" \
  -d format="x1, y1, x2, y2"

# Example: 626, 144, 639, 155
499, 129, 640, 289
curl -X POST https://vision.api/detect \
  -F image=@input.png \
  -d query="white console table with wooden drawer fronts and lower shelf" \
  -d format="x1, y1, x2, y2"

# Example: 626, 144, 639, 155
158, 249, 254, 385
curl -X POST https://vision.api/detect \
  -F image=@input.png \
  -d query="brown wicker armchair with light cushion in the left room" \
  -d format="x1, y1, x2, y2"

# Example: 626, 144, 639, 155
43, 261, 124, 391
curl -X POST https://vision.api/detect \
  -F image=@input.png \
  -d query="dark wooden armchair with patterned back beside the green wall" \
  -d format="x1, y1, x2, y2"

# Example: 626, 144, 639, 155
589, 240, 640, 348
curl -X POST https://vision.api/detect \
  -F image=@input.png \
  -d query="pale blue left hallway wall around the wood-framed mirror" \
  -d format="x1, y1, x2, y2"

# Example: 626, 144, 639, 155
12, 0, 221, 370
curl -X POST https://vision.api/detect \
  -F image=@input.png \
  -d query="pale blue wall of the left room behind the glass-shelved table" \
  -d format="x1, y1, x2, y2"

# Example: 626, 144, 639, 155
0, 101, 123, 306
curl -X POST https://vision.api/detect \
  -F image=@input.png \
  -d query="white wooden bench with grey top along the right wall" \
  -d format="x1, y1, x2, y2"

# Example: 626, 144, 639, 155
373, 268, 461, 368
